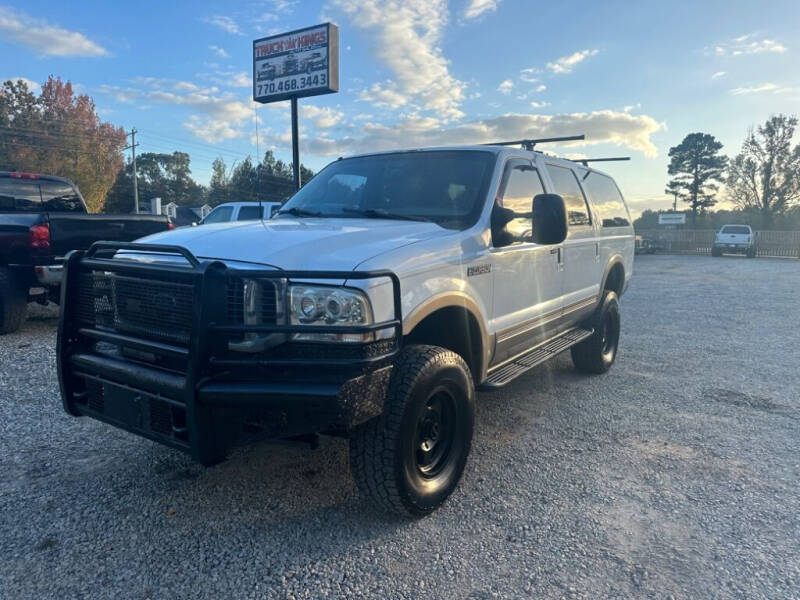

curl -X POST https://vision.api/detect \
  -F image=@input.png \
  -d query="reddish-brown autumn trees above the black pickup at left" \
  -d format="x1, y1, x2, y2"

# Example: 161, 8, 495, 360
0, 76, 126, 212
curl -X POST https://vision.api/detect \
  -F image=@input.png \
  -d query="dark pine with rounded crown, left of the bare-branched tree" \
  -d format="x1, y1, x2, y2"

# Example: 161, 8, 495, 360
665, 133, 727, 220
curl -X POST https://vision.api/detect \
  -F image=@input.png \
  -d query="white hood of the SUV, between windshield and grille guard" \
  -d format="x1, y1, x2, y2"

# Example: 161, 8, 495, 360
137, 218, 453, 270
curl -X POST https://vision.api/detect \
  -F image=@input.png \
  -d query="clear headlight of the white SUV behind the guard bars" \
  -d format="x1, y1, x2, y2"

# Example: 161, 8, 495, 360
289, 285, 374, 342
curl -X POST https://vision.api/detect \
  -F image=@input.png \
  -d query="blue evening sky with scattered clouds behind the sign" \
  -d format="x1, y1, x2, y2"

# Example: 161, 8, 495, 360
0, 0, 800, 214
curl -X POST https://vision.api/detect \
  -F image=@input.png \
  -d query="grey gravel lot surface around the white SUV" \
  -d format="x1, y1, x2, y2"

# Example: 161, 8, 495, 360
0, 256, 800, 600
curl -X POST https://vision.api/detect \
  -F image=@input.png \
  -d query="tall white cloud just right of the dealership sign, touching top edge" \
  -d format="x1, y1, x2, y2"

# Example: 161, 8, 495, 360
332, 0, 466, 119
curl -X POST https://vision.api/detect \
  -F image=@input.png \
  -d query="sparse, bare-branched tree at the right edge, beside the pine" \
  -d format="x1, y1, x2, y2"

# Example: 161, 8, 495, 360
727, 115, 800, 228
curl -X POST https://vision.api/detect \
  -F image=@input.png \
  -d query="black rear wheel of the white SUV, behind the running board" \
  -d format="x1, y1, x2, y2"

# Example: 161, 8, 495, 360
572, 290, 622, 374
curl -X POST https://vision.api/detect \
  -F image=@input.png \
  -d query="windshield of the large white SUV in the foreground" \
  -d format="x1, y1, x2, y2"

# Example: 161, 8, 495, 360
281, 150, 494, 227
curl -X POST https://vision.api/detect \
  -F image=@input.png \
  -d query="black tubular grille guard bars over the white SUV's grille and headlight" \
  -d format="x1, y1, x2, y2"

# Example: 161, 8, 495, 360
57, 242, 403, 458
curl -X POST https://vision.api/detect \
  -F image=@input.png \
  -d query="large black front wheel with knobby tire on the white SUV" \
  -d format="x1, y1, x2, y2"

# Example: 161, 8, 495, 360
350, 345, 475, 517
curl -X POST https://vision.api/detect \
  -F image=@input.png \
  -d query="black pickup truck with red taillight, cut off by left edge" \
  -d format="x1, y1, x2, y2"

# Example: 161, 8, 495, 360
0, 171, 172, 334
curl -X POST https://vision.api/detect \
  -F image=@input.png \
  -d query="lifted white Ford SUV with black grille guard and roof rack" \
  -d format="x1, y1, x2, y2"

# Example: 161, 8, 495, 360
58, 145, 634, 516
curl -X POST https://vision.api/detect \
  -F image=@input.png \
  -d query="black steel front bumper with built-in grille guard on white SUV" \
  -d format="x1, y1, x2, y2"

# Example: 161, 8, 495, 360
57, 242, 403, 464
